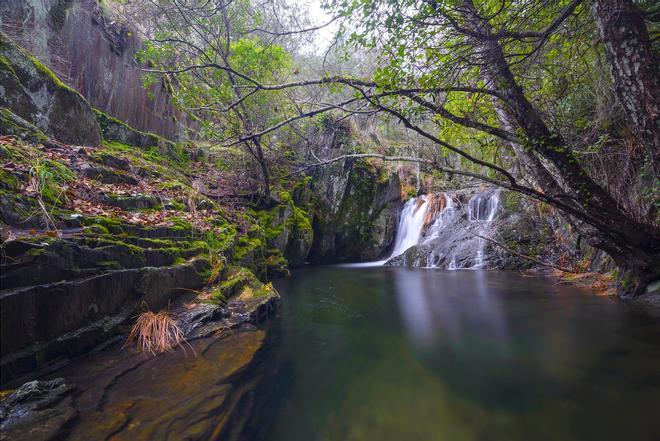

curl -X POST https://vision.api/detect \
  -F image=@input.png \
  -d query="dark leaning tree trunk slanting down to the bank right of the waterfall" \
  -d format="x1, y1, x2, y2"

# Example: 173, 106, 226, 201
460, 0, 660, 295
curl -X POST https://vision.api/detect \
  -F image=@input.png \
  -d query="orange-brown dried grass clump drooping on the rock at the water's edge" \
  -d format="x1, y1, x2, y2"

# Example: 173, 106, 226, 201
123, 311, 186, 355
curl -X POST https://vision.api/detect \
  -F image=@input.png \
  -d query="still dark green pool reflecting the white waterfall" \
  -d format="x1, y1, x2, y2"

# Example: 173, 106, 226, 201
224, 267, 660, 441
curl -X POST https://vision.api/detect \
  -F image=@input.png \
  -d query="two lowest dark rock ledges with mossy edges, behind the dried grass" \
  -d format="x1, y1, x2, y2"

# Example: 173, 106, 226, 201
0, 222, 209, 383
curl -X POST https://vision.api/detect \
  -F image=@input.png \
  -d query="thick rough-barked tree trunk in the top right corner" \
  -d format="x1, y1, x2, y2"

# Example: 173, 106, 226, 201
593, 0, 660, 173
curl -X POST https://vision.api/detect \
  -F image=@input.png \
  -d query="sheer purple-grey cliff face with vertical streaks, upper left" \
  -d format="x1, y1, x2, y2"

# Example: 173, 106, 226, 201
0, 0, 183, 139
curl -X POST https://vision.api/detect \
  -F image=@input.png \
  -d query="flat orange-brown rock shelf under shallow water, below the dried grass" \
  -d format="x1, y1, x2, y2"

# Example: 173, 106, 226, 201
0, 326, 265, 440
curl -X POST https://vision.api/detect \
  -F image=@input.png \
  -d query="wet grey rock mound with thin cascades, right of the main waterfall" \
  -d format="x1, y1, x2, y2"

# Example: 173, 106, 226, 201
387, 188, 554, 269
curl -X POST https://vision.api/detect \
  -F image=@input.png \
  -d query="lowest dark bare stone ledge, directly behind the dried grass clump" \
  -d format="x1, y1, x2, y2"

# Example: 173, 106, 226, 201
0, 258, 210, 383
